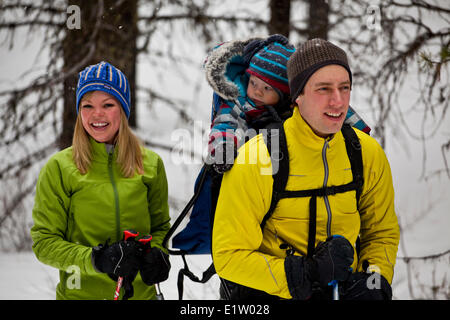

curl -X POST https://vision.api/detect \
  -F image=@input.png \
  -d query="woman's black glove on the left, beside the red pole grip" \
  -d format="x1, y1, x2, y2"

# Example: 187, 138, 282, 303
92, 241, 141, 279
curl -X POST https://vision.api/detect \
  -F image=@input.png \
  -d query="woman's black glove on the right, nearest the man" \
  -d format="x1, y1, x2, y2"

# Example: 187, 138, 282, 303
140, 248, 170, 286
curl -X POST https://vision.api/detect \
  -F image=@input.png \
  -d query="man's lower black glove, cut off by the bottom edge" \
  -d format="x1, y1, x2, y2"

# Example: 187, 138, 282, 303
339, 272, 392, 300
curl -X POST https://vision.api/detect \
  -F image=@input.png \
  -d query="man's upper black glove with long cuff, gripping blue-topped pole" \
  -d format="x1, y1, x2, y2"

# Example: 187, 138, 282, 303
284, 236, 353, 300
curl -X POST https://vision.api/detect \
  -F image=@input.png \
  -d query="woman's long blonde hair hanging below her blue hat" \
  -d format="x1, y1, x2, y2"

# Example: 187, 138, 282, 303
72, 92, 144, 178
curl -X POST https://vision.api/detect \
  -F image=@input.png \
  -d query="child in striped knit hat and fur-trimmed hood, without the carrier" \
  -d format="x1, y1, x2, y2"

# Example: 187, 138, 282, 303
205, 34, 295, 174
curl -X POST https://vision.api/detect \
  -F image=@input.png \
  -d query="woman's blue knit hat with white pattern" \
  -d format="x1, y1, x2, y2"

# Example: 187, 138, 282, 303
76, 61, 131, 118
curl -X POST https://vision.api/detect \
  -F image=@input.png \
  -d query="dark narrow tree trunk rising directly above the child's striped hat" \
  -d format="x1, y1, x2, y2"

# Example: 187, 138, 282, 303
269, 0, 291, 38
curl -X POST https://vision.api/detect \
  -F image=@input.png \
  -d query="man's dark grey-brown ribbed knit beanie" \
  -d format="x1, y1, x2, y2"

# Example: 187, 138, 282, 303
287, 38, 352, 101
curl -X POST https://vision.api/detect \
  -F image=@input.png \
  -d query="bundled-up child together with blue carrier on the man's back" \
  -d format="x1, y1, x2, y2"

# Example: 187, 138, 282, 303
167, 35, 295, 254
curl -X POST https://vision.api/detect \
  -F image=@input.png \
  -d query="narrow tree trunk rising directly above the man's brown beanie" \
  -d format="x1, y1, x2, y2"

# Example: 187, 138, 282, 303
308, 0, 331, 40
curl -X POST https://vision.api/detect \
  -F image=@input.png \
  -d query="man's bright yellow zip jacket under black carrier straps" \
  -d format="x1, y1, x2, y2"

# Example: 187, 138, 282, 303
212, 108, 400, 299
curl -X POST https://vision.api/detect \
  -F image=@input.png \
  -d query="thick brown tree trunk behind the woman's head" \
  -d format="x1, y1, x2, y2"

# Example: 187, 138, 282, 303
59, 0, 138, 149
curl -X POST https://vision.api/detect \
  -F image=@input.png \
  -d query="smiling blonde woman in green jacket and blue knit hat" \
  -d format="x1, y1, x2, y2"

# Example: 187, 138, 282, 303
31, 62, 170, 299
